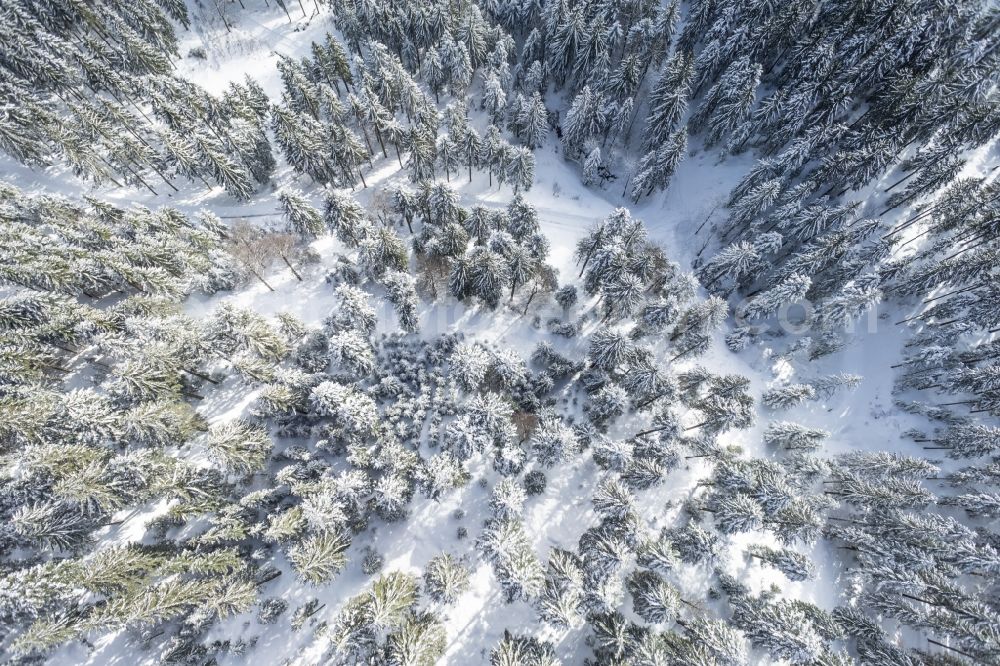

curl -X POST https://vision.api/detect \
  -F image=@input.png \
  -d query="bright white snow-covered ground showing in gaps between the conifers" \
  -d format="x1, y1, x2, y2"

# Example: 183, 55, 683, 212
2, 0, 998, 666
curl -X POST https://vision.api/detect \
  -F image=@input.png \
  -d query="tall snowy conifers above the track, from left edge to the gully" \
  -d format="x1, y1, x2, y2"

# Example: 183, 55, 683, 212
0, 2, 549, 200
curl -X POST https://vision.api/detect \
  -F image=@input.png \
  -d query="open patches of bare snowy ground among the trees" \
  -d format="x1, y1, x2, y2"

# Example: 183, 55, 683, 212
13, 2, 986, 666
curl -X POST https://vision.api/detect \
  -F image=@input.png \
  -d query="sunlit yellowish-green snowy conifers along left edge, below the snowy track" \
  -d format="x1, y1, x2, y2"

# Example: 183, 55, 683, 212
0, 185, 288, 654
